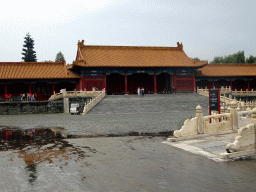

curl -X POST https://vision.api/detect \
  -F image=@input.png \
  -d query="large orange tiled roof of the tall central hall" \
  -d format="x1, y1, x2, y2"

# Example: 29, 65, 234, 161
69, 41, 207, 68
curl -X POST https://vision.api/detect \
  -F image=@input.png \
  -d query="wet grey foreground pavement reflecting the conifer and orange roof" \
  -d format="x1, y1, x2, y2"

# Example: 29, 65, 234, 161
0, 134, 256, 191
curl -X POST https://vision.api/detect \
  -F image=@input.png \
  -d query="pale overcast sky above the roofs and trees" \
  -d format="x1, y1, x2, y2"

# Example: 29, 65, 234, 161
0, 0, 256, 64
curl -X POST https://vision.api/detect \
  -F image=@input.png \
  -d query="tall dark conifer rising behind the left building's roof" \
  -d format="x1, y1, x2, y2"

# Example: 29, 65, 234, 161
21, 33, 37, 62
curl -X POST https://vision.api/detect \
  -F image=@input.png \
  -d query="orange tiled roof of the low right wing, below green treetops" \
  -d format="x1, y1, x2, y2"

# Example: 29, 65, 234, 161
198, 63, 256, 77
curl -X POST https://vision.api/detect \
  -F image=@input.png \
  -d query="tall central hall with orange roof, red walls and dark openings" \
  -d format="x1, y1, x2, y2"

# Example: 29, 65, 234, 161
68, 40, 207, 94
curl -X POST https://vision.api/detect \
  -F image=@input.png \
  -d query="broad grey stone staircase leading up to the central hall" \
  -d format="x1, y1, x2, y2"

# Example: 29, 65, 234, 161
88, 93, 208, 114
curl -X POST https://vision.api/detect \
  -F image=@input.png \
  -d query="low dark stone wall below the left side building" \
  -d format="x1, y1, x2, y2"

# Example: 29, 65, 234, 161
0, 100, 64, 115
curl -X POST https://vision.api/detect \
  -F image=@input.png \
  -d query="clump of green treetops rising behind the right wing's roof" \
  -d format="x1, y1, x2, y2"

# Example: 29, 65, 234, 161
211, 51, 245, 63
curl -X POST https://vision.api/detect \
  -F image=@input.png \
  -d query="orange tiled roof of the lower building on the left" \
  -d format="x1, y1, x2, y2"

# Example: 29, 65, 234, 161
0, 61, 79, 79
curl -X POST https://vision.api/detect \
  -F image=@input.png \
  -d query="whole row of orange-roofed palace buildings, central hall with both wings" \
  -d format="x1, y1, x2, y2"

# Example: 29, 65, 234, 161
0, 40, 256, 100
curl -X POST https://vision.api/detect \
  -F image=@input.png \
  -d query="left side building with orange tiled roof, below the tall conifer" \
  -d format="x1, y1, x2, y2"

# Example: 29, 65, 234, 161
0, 61, 80, 101
